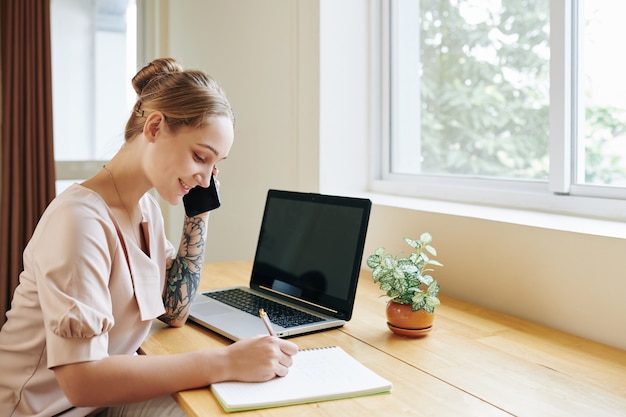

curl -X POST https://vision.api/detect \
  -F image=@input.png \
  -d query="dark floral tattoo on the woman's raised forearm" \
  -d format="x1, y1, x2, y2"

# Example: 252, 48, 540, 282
161, 217, 206, 323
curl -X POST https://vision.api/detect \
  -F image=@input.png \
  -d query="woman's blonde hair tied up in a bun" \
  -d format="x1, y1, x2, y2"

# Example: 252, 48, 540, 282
124, 58, 235, 141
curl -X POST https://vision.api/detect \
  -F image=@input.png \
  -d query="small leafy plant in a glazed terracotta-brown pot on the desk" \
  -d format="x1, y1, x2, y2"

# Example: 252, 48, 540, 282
367, 233, 443, 336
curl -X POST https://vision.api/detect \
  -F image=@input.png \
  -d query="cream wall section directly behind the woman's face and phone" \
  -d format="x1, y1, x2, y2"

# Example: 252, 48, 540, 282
148, 0, 319, 262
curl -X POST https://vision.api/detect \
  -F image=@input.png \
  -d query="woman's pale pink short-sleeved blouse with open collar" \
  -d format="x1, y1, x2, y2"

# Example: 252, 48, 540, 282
0, 184, 175, 417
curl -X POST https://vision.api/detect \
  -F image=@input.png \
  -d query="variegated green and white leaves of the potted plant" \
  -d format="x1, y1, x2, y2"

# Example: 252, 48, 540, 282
367, 233, 443, 313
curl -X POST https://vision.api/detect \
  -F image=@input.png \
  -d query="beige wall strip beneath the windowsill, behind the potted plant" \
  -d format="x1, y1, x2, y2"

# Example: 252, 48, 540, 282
366, 205, 626, 349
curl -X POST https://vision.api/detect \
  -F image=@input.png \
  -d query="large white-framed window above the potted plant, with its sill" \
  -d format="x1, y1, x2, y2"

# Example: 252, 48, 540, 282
374, 0, 626, 218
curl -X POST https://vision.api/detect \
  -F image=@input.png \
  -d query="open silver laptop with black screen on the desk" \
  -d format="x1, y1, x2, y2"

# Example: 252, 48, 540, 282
190, 189, 372, 341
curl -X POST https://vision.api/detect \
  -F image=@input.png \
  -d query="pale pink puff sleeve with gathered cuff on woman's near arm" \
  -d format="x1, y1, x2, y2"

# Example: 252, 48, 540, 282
24, 190, 118, 368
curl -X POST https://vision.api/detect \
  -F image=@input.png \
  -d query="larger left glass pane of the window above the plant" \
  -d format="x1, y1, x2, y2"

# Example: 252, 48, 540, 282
391, 0, 550, 180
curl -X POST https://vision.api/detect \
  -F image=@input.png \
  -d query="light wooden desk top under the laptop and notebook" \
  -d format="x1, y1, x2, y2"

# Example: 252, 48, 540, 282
142, 262, 626, 417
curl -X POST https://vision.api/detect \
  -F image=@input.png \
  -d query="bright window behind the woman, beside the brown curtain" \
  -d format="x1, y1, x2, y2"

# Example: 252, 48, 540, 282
50, 0, 137, 193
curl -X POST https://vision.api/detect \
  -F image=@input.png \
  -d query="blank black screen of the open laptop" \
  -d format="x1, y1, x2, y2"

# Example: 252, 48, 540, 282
250, 190, 371, 320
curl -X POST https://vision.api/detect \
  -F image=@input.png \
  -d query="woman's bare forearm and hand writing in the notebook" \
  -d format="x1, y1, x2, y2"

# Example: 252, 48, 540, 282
54, 336, 298, 407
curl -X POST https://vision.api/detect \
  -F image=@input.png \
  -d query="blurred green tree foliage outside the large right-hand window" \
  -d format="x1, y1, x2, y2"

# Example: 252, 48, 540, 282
414, 0, 626, 184
